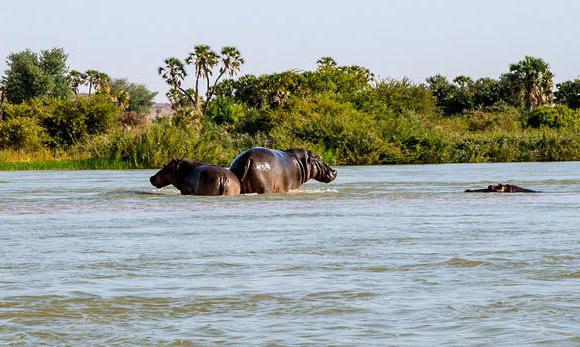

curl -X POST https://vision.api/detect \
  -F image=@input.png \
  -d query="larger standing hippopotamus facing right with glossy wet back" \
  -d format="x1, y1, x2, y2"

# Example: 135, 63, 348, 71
230, 147, 336, 194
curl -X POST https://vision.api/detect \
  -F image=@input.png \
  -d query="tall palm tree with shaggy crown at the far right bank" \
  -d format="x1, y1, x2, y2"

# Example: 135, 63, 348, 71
502, 56, 554, 110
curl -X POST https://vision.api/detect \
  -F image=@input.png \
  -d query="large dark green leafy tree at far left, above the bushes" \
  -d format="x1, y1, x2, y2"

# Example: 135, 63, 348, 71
4, 48, 70, 104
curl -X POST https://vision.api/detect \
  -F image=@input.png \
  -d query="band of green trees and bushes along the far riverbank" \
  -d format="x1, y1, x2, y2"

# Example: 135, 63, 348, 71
0, 45, 580, 170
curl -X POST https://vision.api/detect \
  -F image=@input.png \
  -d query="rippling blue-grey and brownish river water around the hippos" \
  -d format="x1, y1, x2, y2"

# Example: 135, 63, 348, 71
0, 162, 580, 346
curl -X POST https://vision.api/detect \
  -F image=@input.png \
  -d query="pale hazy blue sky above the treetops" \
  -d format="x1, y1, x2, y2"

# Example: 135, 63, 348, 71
0, 0, 580, 101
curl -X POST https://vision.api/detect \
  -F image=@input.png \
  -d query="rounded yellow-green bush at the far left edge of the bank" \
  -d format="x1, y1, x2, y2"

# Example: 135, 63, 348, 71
0, 117, 46, 150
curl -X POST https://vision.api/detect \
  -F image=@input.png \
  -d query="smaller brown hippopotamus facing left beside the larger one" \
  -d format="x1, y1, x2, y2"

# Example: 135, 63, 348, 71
149, 159, 240, 195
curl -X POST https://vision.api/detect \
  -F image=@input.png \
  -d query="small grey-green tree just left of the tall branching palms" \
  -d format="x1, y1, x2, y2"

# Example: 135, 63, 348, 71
111, 78, 157, 113
